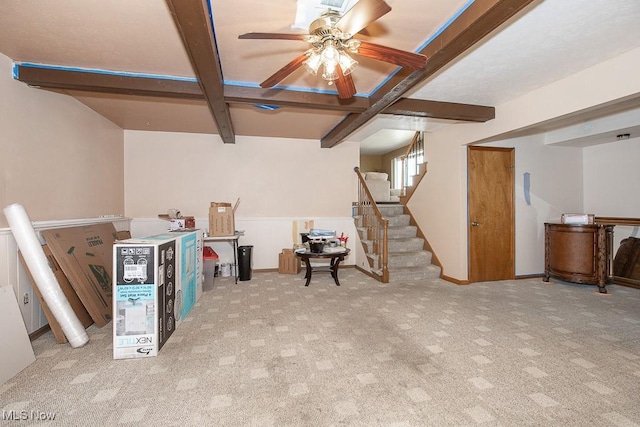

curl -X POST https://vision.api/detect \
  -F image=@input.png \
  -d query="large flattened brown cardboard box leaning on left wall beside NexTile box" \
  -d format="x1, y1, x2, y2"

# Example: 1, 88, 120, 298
42, 223, 116, 327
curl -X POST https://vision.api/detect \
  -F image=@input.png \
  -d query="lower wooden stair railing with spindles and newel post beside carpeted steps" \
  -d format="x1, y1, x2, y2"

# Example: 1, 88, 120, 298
353, 166, 389, 283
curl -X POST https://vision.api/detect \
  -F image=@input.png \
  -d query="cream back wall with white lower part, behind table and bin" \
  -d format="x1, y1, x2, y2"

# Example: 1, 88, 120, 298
125, 131, 360, 269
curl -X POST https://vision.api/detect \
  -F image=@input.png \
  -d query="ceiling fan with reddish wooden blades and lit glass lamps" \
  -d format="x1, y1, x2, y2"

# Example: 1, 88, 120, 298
238, 0, 427, 99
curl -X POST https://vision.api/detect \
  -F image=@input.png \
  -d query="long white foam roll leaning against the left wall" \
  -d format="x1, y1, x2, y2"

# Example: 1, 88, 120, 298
4, 203, 89, 348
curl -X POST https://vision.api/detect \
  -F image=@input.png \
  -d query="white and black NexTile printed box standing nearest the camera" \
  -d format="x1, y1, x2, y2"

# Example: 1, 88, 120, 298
113, 238, 177, 359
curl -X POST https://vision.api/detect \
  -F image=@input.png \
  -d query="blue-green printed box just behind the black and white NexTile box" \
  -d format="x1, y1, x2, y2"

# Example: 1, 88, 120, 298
147, 230, 203, 328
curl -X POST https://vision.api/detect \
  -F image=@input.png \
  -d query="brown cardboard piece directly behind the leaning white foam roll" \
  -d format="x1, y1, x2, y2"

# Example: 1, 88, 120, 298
18, 245, 93, 344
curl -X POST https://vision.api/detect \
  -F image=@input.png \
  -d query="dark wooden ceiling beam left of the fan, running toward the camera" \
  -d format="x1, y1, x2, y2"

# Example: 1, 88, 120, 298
167, 0, 236, 143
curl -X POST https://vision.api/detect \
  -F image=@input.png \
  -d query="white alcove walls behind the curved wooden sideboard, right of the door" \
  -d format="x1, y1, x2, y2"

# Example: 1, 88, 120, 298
483, 134, 640, 276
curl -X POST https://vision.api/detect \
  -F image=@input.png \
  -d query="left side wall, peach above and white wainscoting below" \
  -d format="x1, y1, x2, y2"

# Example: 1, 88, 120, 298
0, 54, 124, 332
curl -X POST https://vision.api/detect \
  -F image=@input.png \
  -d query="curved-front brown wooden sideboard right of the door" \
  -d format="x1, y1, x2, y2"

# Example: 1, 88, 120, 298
543, 223, 614, 293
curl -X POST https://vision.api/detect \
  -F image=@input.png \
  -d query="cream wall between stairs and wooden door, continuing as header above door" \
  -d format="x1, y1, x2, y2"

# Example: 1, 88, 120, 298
409, 49, 640, 281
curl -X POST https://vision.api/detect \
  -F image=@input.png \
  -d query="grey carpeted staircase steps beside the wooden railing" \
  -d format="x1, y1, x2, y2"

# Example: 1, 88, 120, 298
354, 203, 440, 282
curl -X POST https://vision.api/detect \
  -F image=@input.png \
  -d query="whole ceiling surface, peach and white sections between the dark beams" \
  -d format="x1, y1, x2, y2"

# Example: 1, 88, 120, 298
0, 0, 640, 154
